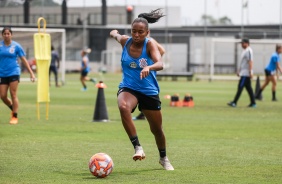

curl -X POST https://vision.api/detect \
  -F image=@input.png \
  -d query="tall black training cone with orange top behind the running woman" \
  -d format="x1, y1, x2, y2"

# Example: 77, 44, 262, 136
93, 81, 109, 122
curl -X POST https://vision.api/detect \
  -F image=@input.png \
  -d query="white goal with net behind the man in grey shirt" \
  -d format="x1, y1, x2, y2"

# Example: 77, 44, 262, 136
209, 38, 282, 80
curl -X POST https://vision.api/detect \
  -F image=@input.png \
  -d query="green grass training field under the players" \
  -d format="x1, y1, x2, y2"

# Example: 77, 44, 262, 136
0, 74, 282, 184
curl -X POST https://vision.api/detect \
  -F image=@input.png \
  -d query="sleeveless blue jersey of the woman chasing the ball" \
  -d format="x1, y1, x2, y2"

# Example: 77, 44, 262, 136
119, 37, 160, 95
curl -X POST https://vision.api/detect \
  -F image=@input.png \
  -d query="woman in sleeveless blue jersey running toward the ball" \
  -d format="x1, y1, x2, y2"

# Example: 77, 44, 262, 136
110, 10, 174, 170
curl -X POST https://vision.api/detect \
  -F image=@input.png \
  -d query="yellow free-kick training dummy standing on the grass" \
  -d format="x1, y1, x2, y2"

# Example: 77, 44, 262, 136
33, 17, 51, 119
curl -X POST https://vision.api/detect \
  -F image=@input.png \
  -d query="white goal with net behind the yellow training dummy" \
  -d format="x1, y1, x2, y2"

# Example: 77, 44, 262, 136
0, 27, 66, 85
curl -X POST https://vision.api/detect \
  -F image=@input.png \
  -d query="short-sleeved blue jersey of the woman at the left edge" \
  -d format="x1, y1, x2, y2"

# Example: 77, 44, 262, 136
0, 41, 25, 77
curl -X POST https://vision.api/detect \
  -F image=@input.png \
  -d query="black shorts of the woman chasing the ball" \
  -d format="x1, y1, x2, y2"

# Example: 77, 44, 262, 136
117, 88, 161, 113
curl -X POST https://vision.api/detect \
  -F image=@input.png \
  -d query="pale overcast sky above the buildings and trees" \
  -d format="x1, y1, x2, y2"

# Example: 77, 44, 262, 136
54, 0, 282, 25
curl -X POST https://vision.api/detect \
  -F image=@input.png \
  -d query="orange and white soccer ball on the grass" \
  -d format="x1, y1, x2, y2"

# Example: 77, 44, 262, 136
89, 153, 114, 178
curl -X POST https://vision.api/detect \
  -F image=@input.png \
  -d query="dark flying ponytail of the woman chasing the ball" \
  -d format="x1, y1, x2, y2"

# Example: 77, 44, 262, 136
132, 8, 165, 28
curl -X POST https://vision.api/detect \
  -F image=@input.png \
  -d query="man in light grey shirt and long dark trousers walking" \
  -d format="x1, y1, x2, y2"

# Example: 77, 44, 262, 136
228, 38, 256, 107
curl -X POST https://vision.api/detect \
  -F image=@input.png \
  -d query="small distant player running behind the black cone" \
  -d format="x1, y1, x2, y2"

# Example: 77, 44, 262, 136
80, 48, 96, 91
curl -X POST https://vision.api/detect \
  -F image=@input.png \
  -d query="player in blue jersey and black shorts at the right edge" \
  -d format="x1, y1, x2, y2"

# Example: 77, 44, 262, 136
256, 44, 282, 101
